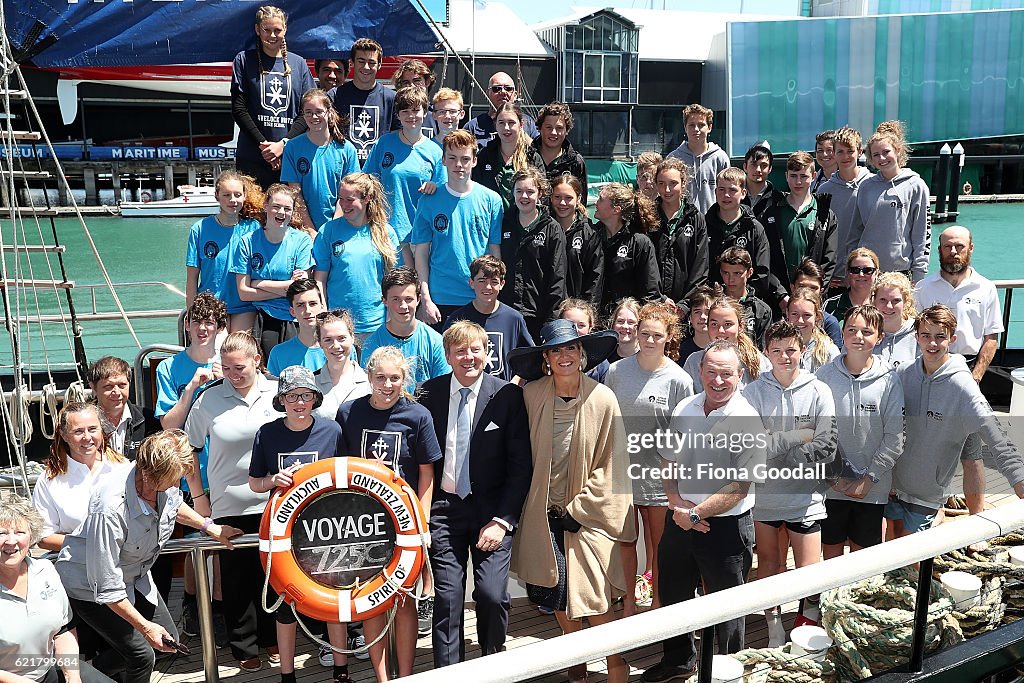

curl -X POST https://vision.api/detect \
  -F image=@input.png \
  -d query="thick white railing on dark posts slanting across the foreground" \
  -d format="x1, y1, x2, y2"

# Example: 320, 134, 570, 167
406, 502, 1024, 683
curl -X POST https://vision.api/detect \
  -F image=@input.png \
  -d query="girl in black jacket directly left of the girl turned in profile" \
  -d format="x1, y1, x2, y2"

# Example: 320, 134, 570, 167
551, 175, 604, 310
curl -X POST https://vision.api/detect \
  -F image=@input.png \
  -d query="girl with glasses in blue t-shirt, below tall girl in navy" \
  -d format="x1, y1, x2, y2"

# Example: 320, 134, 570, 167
281, 88, 359, 230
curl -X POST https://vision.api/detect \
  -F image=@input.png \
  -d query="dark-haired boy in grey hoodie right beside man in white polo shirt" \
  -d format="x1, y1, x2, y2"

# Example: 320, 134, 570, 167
743, 321, 837, 647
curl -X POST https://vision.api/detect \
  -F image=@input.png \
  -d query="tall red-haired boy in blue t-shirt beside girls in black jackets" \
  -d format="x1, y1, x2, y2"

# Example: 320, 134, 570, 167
410, 130, 503, 325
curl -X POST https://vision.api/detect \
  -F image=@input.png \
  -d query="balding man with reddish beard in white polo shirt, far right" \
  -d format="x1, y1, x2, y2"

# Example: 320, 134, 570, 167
913, 225, 1004, 514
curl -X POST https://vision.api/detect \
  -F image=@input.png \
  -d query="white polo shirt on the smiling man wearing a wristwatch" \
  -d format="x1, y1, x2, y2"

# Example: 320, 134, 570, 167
658, 387, 767, 517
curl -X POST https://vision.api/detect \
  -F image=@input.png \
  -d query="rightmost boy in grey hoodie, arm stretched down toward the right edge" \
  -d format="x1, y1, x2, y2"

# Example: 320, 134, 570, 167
886, 304, 1024, 536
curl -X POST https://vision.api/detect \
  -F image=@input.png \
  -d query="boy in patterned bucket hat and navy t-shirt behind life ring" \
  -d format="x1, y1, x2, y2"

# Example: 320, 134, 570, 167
249, 366, 350, 682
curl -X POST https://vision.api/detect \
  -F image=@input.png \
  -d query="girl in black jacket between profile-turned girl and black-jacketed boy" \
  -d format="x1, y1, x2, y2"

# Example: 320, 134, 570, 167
647, 158, 709, 313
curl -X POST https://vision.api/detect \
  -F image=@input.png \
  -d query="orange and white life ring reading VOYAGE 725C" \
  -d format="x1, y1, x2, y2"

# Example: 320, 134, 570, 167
259, 458, 427, 623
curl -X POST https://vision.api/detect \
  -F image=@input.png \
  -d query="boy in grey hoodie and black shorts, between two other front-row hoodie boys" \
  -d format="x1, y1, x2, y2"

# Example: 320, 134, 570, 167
817, 305, 903, 559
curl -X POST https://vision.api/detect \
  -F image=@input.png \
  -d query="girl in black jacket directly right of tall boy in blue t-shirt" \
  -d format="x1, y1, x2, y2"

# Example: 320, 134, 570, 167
498, 168, 565, 339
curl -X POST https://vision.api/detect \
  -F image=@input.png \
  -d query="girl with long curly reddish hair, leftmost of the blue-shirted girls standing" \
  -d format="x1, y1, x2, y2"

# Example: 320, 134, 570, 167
185, 171, 259, 321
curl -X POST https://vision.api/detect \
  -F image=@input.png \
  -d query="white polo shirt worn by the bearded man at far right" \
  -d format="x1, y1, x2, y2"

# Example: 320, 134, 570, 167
913, 267, 1004, 355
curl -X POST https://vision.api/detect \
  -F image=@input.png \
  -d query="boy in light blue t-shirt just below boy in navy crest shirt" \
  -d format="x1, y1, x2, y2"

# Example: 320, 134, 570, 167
362, 87, 446, 265
